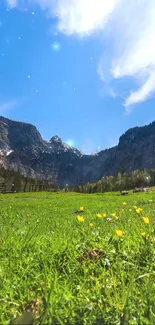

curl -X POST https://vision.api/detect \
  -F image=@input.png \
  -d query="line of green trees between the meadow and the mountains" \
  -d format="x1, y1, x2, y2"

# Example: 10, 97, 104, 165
0, 167, 155, 193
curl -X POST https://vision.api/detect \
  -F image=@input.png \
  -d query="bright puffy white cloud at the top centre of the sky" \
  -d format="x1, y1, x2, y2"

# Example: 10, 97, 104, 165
33, 0, 122, 35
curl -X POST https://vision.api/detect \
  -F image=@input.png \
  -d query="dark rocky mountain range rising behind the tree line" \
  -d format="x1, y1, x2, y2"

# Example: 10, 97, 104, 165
0, 116, 155, 186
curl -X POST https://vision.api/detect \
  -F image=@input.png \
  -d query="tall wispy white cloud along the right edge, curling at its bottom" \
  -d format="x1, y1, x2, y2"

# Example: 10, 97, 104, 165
108, 0, 155, 112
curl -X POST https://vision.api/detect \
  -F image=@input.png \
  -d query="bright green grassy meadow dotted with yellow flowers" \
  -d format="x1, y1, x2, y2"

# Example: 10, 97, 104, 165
0, 193, 155, 325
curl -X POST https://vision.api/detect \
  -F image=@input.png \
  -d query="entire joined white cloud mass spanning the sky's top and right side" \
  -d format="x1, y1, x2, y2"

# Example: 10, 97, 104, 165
7, 0, 155, 111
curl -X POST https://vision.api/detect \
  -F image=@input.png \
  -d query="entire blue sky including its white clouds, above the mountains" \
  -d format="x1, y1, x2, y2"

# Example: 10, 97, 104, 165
0, 0, 155, 153
